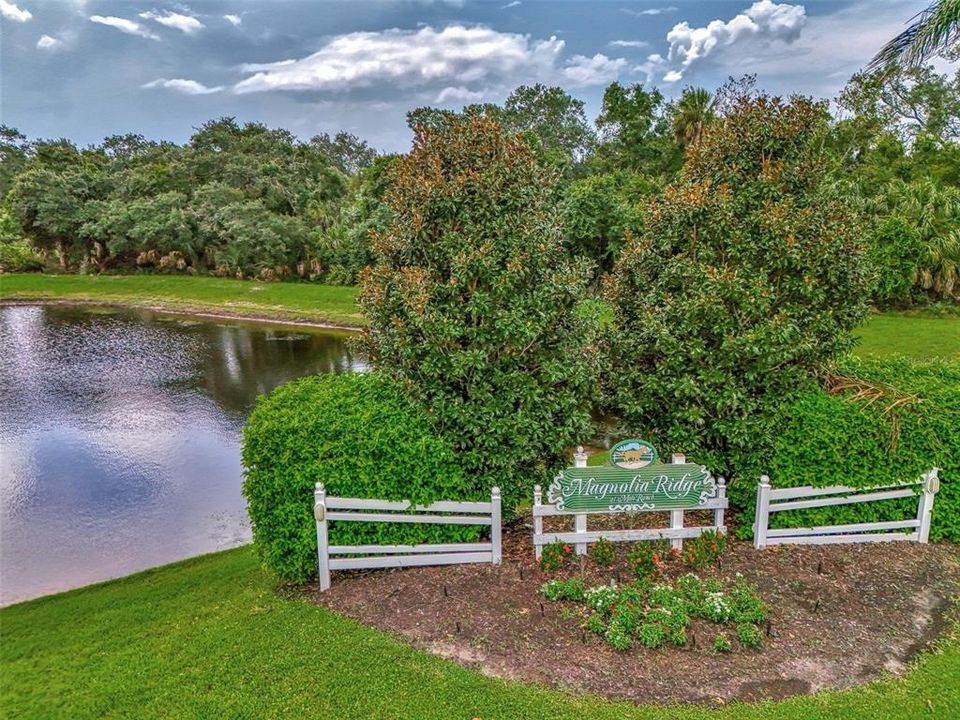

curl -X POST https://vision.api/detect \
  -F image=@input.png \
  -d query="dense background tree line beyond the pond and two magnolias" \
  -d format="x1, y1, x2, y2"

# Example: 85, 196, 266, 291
0, 66, 960, 305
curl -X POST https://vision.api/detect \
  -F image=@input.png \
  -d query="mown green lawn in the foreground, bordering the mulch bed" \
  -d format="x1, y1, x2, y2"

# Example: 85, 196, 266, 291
0, 548, 960, 720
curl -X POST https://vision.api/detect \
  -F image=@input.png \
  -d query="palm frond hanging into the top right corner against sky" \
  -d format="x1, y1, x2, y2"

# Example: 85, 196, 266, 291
870, 0, 960, 70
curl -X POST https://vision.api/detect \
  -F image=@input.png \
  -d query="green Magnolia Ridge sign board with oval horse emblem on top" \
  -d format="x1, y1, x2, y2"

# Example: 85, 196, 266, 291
547, 440, 717, 512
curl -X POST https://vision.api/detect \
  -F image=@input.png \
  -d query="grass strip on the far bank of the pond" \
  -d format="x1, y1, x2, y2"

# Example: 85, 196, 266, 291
0, 274, 363, 325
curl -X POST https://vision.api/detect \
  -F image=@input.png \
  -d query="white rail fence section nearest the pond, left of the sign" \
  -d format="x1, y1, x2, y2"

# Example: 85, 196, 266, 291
313, 483, 502, 590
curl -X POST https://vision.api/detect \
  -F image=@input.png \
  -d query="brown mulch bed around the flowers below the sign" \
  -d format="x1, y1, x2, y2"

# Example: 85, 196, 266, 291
313, 521, 960, 703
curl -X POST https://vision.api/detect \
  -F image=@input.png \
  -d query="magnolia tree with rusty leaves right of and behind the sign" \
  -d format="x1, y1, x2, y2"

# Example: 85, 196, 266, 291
606, 96, 871, 469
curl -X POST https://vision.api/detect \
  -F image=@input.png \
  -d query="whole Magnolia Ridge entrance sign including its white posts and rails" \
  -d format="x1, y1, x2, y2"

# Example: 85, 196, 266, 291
533, 438, 727, 560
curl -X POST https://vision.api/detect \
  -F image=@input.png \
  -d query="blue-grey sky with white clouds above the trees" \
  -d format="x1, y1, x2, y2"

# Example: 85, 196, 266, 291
0, 0, 928, 152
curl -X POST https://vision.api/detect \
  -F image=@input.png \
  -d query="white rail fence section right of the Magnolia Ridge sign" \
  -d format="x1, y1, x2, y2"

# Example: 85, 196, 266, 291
753, 468, 940, 549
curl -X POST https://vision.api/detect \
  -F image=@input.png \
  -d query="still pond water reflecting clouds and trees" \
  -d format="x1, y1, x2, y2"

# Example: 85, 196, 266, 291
0, 305, 361, 605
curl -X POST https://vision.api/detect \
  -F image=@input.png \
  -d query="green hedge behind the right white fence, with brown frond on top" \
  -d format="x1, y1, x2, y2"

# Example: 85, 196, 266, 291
729, 358, 960, 541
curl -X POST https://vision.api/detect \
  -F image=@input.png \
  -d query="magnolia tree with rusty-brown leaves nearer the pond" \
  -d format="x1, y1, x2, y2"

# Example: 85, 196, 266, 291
360, 116, 597, 500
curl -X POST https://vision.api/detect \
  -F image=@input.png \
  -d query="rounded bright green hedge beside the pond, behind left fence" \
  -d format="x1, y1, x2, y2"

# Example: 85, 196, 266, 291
243, 374, 478, 582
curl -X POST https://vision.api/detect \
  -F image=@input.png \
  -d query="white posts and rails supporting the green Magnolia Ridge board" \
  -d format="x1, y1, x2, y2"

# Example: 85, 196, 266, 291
533, 452, 728, 560
